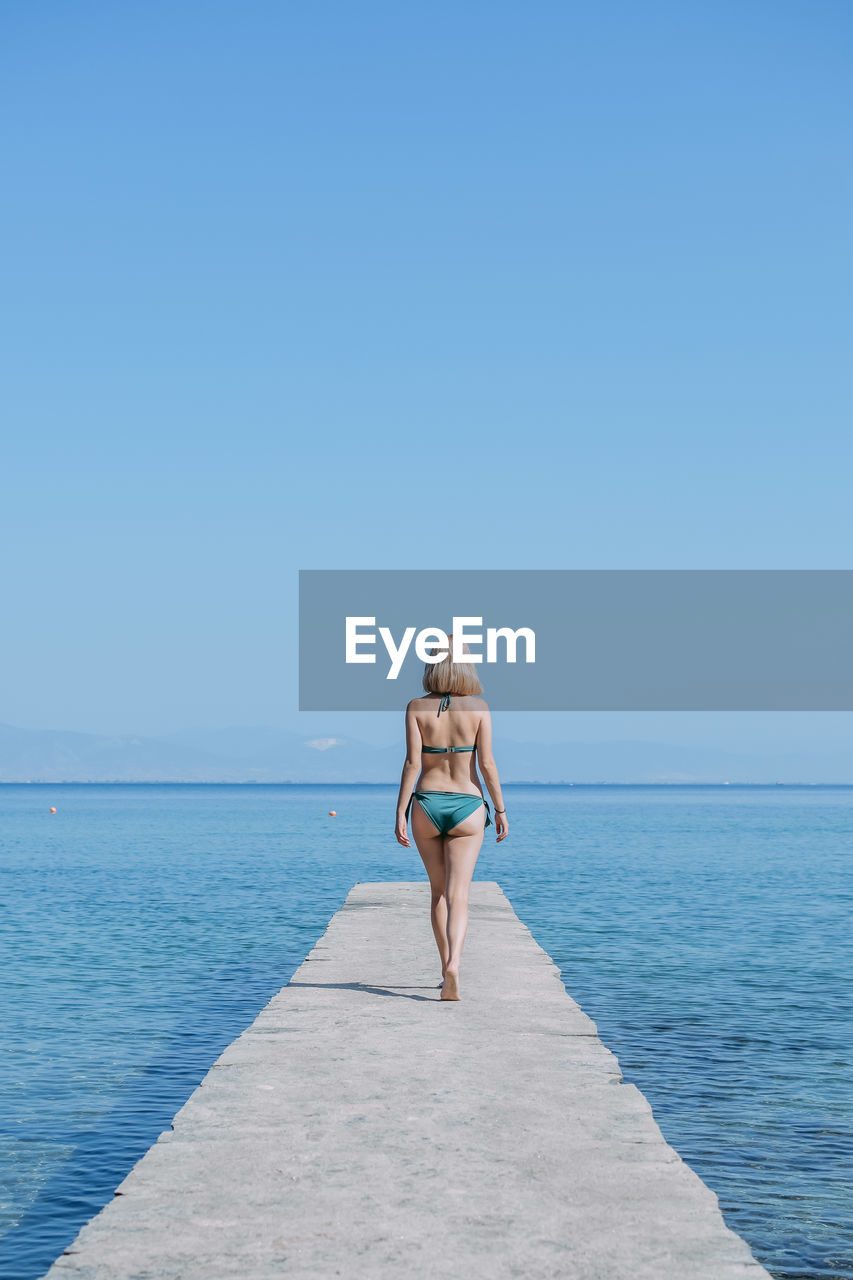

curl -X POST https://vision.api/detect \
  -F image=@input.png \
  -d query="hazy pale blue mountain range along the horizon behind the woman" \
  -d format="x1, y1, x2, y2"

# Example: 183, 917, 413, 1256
0, 724, 853, 783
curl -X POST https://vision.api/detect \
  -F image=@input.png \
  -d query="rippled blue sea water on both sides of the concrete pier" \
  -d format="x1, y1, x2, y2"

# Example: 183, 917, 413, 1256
0, 785, 853, 1280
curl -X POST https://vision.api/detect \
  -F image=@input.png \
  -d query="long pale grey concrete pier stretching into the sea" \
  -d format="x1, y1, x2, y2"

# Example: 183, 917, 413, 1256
47, 881, 768, 1280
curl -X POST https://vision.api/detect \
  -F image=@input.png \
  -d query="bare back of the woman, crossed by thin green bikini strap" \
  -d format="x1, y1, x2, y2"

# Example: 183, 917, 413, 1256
409, 694, 488, 795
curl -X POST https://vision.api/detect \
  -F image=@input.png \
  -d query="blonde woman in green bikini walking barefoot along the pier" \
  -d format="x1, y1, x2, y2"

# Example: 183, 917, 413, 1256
394, 654, 510, 1000
